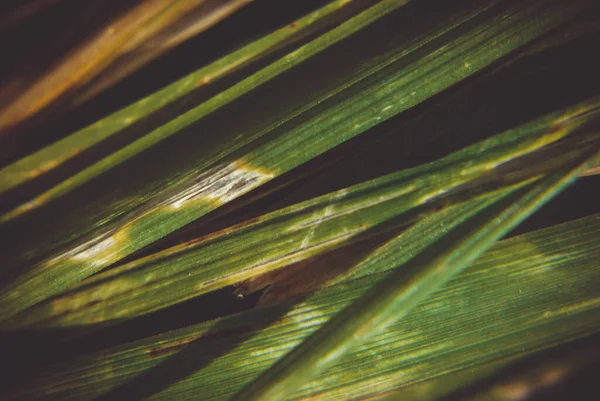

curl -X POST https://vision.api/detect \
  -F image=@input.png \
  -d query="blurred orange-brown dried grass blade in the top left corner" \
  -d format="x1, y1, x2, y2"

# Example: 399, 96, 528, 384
0, 0, 249, 132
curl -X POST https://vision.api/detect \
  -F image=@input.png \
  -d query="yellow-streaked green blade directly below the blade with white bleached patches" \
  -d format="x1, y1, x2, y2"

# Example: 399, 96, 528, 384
0, 101, 598, 329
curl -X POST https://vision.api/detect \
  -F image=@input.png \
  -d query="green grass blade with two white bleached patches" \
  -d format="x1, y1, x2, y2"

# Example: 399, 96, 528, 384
0, 2, 596, 324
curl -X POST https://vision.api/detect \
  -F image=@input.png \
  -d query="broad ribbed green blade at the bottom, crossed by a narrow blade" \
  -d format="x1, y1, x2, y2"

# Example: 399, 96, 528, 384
3, 211, 600, 401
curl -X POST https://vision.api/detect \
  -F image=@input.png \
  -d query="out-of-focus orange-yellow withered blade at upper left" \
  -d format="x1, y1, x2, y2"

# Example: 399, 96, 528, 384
0, 0, 252, 131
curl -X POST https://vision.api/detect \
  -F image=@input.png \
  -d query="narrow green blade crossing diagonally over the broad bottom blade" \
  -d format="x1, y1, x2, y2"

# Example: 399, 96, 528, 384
234, 146, 600, 400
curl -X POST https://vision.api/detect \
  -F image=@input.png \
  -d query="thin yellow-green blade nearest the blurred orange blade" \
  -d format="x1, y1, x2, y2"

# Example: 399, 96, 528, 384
0, 0, 376, 193
